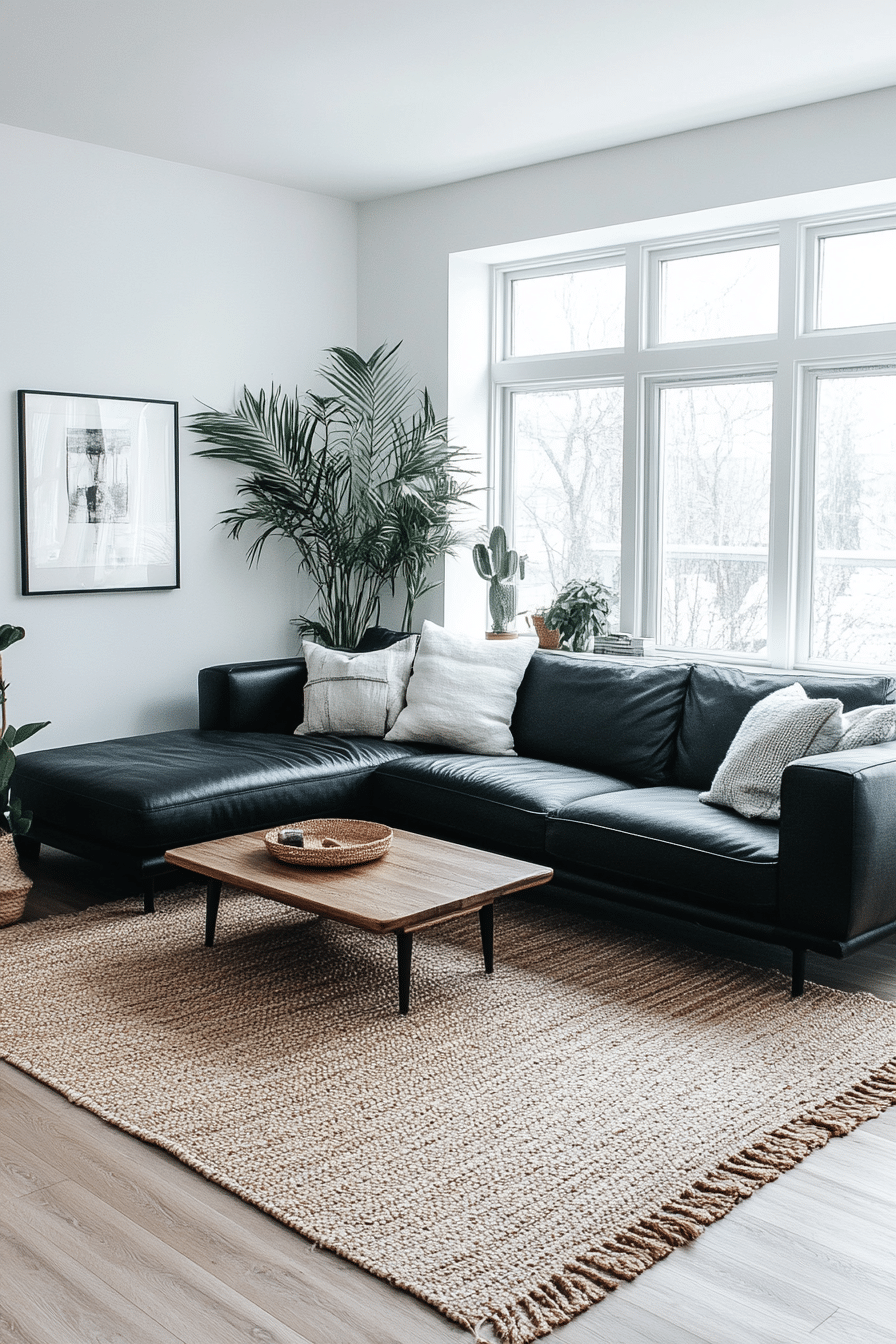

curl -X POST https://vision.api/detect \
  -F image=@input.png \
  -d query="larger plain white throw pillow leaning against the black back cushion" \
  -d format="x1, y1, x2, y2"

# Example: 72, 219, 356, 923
386, 621, 536, 755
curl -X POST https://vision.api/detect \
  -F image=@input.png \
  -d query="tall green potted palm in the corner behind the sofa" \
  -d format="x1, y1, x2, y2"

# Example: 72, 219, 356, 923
191, 345, 472, 648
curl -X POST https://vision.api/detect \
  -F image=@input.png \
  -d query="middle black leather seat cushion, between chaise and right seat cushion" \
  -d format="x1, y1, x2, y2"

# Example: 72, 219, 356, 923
372, 749, 631, 853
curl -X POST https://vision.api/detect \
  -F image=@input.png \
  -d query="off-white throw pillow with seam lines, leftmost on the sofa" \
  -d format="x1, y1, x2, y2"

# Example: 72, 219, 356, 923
296, 636, 416, 738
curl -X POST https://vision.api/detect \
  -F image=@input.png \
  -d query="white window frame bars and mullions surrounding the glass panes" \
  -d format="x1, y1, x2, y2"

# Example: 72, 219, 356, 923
488, 203, 896, 672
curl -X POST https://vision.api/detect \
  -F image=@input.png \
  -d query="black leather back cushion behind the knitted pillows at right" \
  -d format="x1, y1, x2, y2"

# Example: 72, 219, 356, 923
674, 663, 896, 789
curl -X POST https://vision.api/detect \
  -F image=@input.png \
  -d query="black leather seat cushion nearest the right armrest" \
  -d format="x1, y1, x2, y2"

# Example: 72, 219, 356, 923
547, 788, 778, 906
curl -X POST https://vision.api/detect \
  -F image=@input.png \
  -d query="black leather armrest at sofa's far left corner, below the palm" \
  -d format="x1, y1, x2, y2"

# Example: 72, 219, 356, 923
199, 659, 306, 732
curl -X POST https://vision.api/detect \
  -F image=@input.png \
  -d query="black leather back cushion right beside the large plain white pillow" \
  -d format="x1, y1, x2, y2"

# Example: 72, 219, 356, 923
510, 653, 690, 784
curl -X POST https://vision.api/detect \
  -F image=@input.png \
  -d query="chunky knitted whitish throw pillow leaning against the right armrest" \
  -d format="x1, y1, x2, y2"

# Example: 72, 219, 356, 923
700, 681, 844, 821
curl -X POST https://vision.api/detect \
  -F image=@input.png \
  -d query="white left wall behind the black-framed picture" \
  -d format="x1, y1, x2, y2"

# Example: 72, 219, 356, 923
0, 126, 356, 750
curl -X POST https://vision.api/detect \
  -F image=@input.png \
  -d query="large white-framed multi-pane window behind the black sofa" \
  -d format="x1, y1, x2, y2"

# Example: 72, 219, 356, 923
492, 212, 896, 667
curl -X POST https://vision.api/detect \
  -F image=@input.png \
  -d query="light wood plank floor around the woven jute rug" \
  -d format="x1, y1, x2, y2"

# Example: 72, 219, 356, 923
0, 851, 896, 1344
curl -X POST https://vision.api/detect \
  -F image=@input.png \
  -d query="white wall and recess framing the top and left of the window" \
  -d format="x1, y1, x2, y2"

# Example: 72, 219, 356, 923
359, 87, 896, 624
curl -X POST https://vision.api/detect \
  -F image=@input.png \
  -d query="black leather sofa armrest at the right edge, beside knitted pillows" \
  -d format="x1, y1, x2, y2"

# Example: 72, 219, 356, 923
778, 742, 896, 942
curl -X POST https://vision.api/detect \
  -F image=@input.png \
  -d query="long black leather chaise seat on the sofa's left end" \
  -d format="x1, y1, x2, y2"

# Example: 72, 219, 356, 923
15, 730, 421, 849
